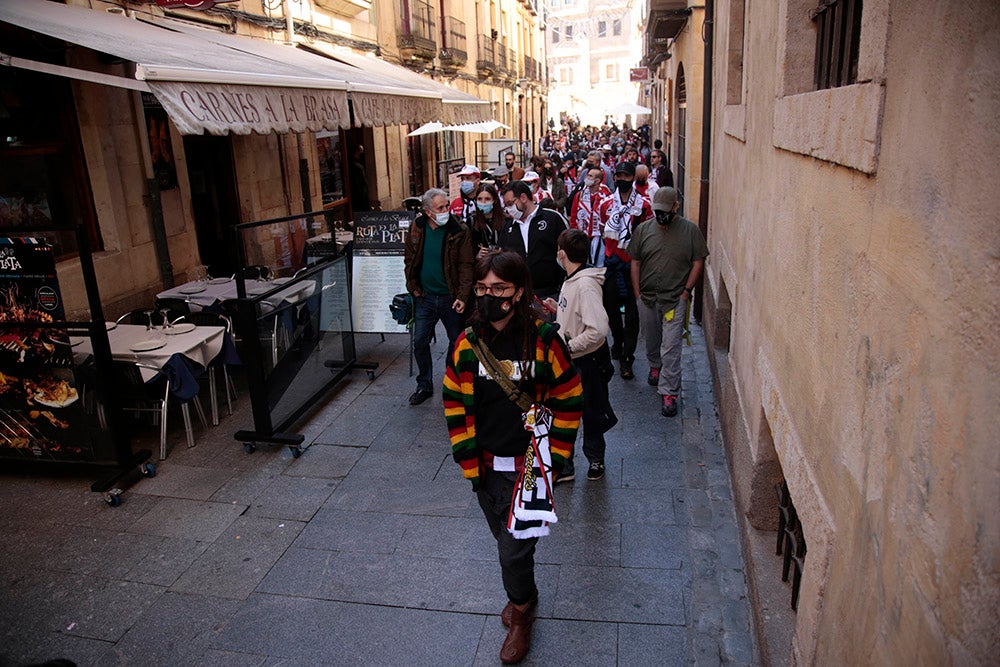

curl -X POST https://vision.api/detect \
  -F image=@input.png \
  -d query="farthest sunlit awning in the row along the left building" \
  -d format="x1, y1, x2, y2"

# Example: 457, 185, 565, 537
308, 44, 493, 125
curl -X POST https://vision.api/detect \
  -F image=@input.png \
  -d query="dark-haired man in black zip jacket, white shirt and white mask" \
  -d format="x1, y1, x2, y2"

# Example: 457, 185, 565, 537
500, 181, 566, 300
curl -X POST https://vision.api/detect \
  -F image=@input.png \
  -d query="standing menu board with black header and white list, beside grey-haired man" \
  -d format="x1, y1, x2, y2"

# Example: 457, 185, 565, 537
351, 211, 414, 333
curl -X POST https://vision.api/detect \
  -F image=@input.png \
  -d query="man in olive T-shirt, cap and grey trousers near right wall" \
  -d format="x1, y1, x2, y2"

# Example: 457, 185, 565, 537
628, 187, 708, 417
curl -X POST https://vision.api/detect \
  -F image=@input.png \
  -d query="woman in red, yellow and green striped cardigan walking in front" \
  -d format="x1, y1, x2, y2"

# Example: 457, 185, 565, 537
443, 252, 583, 663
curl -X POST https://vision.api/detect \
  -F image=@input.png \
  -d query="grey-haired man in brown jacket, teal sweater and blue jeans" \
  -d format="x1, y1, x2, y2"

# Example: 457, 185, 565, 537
403, 188, 473, 405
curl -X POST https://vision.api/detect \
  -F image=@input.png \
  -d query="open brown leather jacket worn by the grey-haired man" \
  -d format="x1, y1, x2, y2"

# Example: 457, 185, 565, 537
403, 213, 474, 304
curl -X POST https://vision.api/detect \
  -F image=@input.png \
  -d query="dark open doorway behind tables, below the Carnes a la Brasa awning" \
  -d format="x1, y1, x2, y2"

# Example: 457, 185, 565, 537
184, 135, 242, 276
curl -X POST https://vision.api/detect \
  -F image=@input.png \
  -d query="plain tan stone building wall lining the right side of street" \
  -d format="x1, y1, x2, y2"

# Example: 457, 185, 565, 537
703, 0, 1000, 665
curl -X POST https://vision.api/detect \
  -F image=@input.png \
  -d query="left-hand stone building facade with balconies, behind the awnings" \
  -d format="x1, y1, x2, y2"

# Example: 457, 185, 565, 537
0, 0, 546, 317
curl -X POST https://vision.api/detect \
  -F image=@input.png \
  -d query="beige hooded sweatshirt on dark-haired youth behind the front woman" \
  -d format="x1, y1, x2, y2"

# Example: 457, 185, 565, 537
556, 266, 611, 359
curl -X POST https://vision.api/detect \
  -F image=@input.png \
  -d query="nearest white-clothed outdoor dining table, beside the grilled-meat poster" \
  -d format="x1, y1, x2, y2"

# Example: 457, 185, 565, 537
70, 323, 232, 425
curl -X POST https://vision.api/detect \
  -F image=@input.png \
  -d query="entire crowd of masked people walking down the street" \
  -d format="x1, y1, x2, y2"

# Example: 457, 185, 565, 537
396, 123, 708, 664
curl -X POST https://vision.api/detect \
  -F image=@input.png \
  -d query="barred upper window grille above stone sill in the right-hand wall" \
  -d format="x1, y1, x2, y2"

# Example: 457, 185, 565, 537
809, 0, 862, 90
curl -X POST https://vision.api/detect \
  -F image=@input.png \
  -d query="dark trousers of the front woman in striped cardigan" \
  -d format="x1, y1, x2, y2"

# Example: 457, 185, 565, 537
476, 468, 538, 604
